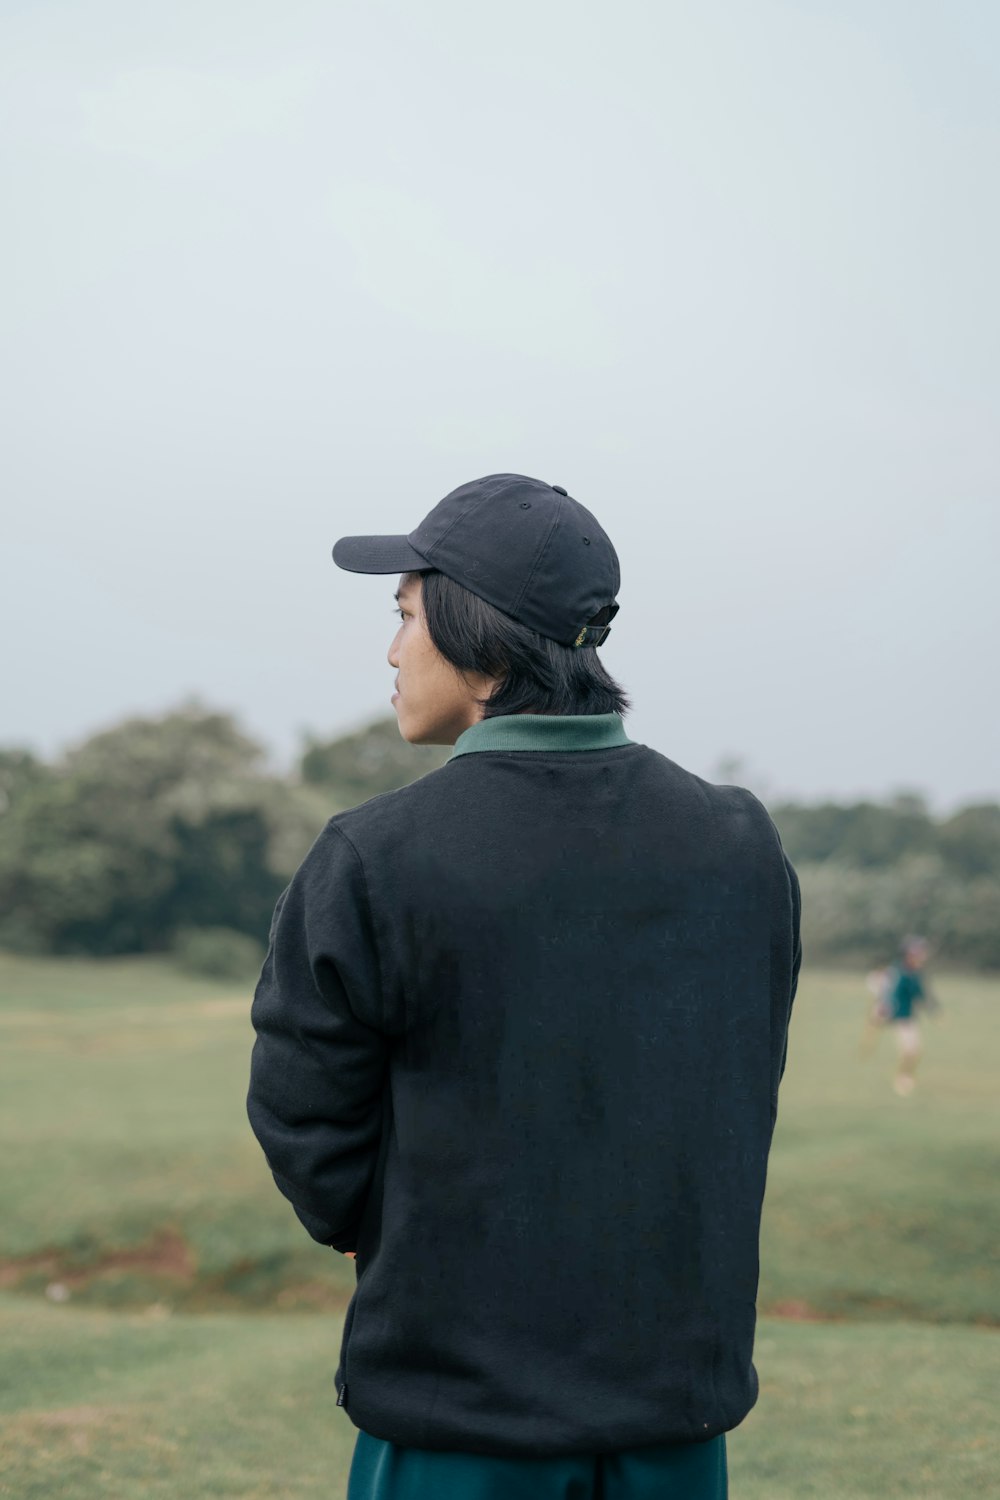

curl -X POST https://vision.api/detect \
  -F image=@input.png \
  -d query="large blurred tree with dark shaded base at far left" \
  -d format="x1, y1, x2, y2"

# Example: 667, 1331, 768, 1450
0, 704, 322, 953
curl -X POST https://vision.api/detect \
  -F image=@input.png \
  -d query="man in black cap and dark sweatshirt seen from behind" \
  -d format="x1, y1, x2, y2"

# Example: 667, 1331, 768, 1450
249, 474, 801, 1500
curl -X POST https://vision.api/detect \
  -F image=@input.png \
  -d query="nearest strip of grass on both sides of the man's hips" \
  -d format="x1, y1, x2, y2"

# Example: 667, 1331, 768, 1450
0, 1298, 1000, 1500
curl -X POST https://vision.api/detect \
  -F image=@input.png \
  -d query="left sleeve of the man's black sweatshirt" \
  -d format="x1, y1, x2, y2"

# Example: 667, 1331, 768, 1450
247, 822, 387, 1251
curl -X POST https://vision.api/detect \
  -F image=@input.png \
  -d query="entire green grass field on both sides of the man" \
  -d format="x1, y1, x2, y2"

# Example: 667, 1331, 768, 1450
0, 957, 1000, 1500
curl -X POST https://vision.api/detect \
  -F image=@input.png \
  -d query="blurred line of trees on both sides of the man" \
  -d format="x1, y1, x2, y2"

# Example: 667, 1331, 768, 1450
0, 702, 1000, 972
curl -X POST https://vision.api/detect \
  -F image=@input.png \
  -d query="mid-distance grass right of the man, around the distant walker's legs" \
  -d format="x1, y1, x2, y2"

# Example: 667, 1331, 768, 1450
760, 972, 1000, 1325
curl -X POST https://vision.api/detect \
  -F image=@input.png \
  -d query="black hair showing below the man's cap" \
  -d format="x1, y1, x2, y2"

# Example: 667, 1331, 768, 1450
406, 569, 631, 719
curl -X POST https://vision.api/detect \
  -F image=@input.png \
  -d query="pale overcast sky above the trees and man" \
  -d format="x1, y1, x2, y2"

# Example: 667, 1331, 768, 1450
0, 0, 1000, 809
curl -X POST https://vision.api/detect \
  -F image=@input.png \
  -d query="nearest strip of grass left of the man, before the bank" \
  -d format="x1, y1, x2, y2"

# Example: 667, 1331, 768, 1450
0, 1298, 354, 1500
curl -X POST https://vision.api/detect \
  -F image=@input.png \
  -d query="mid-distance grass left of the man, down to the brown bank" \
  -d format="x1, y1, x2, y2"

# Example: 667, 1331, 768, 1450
0, 956, 354, 1307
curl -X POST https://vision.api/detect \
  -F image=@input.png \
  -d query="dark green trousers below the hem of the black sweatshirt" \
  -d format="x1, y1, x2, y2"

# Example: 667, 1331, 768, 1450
348, 1433, 729, 1500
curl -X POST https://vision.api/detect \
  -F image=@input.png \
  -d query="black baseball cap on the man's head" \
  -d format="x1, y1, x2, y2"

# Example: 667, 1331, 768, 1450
333, 474, 621, 647
